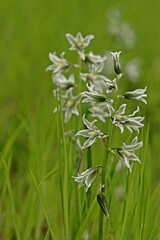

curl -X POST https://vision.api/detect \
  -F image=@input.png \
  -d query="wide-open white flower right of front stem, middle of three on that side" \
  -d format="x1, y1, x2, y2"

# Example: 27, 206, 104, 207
108, 104, 144, 133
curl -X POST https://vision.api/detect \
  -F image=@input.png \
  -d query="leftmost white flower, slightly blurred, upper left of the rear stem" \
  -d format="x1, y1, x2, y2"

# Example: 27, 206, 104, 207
46, 52, 70, 73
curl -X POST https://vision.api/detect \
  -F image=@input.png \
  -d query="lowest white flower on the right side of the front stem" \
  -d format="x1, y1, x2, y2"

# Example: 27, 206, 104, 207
117, 137, 143, 172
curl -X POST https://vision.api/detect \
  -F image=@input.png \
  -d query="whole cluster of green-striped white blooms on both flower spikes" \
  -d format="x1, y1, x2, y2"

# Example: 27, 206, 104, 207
46, 33, 147, 216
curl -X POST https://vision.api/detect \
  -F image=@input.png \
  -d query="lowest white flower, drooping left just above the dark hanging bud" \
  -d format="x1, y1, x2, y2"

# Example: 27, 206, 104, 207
73, 166, 99, 192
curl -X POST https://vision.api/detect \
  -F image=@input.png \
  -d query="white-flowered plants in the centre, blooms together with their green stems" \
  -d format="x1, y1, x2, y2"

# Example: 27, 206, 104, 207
47, 32, 147, 240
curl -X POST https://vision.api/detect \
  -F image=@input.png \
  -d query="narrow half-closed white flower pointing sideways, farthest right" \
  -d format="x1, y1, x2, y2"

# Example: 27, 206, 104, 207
123, 87, 147, 104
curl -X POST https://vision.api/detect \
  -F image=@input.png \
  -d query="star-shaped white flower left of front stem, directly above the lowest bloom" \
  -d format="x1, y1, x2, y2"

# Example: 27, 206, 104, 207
76, 115, 106, 149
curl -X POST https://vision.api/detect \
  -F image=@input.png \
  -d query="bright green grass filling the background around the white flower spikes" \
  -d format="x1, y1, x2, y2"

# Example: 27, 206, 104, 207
0, 0, 160, 240
